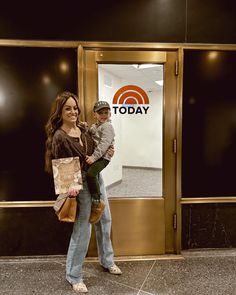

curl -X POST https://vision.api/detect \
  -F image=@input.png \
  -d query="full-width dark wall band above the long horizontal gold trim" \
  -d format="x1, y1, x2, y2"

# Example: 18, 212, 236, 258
0, 0, 236, 43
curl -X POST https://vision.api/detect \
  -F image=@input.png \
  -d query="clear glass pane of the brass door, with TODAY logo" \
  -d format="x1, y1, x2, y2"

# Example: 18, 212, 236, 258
98, 64, 163, 197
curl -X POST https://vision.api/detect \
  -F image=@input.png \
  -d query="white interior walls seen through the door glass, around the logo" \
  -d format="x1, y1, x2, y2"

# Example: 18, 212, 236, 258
98, 67, 163, 185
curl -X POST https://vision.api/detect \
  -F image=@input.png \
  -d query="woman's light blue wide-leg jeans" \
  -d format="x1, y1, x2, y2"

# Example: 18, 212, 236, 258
66, 173, 114, 284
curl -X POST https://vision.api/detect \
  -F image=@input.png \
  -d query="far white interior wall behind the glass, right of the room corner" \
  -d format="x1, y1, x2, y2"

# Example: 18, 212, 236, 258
120, 89, 162, 168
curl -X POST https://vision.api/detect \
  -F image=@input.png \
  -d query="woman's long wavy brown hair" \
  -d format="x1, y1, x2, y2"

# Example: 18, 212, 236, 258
45, 91, 80, 173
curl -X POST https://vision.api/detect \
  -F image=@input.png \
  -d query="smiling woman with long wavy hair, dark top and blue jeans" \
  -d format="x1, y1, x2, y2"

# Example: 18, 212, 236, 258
46, 91, 121, 293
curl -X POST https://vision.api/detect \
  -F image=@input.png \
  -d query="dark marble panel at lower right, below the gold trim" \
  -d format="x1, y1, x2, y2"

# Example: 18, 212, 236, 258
182, 204, 236, 249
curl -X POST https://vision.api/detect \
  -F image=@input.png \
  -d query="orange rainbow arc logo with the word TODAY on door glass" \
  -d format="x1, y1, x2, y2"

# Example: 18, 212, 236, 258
112, 85, 149, 114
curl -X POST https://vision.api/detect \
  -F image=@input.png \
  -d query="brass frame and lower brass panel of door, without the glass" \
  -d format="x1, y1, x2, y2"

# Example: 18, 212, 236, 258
80, 48, 180, 256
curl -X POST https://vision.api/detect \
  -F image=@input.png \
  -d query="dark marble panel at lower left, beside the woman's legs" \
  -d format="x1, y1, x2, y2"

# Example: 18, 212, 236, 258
0, 208, 72, 256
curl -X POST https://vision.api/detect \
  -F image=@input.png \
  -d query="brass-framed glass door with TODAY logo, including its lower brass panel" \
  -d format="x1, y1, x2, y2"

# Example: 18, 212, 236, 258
84, 50, 177, 255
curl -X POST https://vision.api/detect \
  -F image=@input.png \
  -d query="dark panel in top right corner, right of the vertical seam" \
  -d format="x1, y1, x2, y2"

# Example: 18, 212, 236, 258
186, 0, 236, 44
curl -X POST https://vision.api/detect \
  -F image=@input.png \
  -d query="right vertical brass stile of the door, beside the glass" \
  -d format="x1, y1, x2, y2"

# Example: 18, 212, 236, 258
163, 51, 178, 253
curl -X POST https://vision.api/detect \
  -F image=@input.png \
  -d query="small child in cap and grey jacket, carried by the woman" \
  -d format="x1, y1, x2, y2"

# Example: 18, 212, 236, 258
86, 101, 115, 223
